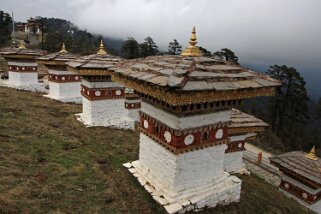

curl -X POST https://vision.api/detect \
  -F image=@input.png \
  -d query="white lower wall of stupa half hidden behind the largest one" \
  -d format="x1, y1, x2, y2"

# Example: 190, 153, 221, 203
224, 151, 246, 173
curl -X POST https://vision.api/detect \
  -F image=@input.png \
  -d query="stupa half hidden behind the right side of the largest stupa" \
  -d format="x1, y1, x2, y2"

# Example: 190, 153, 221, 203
224, 109, 268, 174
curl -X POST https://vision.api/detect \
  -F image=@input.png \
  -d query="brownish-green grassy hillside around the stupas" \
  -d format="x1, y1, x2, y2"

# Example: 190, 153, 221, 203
0, 87, 309, 214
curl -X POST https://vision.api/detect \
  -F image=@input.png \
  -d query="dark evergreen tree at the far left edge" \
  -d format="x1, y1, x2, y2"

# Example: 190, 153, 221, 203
0, 11, 12, 47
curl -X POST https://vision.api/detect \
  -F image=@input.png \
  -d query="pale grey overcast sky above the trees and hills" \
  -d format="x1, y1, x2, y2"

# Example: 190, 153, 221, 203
0, 0, 321, 95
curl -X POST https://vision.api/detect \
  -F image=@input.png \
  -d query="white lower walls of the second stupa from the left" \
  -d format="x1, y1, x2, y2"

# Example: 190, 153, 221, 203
46, 81, 82, 103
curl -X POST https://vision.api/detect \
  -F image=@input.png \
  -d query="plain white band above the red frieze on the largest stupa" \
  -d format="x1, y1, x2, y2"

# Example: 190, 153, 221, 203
141, 101, 231, 130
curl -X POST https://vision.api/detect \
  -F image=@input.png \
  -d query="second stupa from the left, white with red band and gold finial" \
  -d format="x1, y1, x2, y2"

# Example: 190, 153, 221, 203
37, 44, 82, 103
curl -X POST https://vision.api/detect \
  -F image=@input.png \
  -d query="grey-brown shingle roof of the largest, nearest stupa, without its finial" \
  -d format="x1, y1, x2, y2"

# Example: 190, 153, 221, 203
112, 55, 280, 91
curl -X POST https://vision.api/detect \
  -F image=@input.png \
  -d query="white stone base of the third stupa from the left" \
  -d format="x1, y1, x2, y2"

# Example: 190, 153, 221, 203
75, 113, 135, 130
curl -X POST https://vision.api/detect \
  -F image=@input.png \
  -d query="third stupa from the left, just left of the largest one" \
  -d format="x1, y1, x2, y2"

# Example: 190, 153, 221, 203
67, 41, 140, 129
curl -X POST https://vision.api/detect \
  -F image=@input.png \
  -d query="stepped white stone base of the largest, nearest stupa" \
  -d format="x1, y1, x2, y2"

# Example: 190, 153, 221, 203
123, 161, 242, 214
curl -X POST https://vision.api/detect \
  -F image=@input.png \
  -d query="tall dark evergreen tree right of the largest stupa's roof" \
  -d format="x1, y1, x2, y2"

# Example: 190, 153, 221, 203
267, 65, 309, 150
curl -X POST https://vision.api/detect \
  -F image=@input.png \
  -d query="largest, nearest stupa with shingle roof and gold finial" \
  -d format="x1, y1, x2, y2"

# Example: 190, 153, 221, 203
109, 28, 280, 213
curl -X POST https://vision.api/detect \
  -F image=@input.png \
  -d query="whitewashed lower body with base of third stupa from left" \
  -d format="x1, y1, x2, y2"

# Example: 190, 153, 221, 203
78, 97, 135, 130
